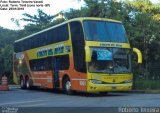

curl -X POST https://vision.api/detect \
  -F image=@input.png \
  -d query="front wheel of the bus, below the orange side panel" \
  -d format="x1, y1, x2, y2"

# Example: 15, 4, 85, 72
64, 77, 72, 95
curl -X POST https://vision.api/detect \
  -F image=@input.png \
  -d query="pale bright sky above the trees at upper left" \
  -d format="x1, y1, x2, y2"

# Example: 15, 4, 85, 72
0, 0, 160, 30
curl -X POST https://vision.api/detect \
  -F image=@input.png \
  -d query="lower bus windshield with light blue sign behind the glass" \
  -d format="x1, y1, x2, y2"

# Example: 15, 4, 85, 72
88, 48, 131, 74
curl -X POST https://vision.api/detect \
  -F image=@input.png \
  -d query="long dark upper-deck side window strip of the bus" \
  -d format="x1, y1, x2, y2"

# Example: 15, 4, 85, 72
14, 24, 69, 52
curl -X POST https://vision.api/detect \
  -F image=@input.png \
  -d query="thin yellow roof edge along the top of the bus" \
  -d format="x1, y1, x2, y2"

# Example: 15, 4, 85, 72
15, 17, 122, 43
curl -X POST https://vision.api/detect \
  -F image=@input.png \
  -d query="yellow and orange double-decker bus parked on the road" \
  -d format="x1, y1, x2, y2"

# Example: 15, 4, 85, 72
13, 17, 142, 94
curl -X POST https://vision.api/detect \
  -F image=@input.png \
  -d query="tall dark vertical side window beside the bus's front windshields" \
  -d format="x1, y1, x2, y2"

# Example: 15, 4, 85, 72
70, 21, 86, 72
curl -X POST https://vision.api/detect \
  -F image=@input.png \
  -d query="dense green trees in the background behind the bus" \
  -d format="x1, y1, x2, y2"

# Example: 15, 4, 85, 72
0, 0, 160, 89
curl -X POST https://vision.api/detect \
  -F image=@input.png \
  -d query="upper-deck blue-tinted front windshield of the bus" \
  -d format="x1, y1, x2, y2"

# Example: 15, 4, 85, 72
84, 20, 128, 43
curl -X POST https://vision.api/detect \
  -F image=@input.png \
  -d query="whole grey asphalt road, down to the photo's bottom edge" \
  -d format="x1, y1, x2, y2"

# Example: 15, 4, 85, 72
0, 88, 160, 113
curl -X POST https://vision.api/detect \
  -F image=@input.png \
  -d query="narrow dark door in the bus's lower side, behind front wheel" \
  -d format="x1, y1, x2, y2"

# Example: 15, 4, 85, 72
53, 57, 60, 88
